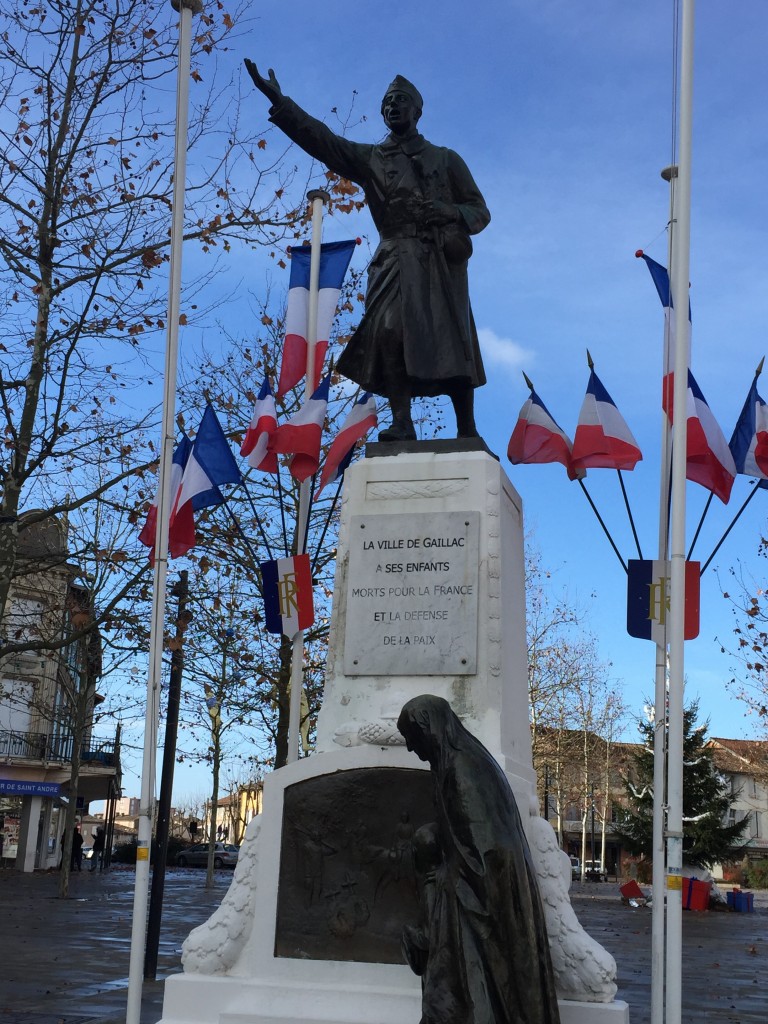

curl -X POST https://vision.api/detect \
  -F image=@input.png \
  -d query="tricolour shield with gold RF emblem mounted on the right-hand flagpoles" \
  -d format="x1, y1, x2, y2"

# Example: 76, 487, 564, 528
627, 558, 701, 645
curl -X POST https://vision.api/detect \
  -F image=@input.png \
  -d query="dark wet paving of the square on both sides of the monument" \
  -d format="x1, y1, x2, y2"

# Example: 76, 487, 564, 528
0, 867, 768, 1024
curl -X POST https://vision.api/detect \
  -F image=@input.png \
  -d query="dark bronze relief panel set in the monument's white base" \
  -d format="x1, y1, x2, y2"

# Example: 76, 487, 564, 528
274, 768, 434, 964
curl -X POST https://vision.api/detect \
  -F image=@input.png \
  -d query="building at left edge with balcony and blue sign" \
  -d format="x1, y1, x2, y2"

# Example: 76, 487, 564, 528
0, 513, 120, 871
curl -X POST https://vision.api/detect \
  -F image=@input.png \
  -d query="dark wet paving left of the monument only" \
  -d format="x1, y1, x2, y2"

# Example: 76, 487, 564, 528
0, 866, 231, 1024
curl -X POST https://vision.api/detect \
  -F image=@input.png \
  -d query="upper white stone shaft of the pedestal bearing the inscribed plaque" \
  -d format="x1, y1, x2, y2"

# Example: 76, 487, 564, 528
317, 452, 535, 805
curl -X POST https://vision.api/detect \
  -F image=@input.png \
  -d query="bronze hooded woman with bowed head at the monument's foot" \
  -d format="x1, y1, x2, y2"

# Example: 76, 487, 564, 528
397, 694, 560, 1024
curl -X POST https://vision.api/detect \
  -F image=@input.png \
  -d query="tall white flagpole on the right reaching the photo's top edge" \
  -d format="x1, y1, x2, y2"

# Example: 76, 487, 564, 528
666, 0, 694, 1024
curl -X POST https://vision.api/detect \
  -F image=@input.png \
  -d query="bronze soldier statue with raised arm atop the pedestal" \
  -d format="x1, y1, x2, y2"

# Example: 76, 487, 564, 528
246, 59, 490, 441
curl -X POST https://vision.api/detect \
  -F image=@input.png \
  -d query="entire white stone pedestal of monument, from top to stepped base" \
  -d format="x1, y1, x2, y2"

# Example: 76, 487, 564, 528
157, 452, 629, 1024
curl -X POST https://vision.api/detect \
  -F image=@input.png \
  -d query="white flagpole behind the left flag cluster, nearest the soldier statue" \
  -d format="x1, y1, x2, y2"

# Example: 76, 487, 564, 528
287, 188, 331, 764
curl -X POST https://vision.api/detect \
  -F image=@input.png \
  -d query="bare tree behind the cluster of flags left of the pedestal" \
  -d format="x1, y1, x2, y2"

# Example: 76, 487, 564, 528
169, 273, 370, 772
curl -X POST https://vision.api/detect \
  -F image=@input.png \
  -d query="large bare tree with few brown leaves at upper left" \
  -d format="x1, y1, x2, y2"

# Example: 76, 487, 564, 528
0, 0, 307, 616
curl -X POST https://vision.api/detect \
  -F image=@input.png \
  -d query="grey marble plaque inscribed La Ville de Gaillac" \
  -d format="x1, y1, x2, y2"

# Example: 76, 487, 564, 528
344, 511, 480, 676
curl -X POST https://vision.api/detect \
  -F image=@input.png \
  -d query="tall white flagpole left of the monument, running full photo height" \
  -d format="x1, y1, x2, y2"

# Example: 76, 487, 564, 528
125, 0, 203, 1024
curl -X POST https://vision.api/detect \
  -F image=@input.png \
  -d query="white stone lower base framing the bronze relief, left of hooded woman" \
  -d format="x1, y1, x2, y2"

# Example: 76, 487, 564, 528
163, 746, 430, 1024
